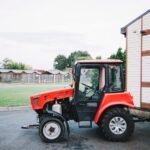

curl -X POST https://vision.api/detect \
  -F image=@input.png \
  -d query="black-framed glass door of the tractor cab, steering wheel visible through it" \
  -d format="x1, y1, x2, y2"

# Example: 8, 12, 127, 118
75, 65, 105, 121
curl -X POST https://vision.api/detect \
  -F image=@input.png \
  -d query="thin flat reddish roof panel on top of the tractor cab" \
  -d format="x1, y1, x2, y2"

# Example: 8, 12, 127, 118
76, 59, 122, 64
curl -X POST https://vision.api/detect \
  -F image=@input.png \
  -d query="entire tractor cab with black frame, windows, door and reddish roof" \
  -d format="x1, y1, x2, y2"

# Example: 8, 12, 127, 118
73, 60, 124, 121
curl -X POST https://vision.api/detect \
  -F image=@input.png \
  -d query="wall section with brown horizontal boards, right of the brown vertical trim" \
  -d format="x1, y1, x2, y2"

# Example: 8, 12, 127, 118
141, 13, 150, 109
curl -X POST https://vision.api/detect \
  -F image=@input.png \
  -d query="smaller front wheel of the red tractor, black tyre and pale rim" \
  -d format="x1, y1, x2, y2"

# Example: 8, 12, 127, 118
39, 117, 65, 143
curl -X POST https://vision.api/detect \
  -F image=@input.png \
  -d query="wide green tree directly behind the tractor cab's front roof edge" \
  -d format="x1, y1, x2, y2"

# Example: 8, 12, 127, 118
68, 51, 92, 67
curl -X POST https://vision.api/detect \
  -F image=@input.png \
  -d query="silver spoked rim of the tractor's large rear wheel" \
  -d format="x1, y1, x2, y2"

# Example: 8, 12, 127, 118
109, 117, 127, 135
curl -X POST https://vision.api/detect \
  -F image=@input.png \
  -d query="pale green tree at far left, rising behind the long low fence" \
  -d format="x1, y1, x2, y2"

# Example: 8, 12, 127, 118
2, 58, 32, 70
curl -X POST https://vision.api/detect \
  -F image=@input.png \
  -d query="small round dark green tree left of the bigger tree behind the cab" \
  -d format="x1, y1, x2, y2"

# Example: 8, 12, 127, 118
54, 55, 67, 70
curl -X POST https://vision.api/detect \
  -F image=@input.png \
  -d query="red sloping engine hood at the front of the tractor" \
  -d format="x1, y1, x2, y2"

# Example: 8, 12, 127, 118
30, 88, 73, 110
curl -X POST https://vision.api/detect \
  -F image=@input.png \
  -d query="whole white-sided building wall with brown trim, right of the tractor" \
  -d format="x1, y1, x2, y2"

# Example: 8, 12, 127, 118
127, 13, 150, 108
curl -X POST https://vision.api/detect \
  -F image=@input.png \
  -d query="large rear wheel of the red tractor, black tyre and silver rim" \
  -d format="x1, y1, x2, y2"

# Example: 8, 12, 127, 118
100, 107, 134, 141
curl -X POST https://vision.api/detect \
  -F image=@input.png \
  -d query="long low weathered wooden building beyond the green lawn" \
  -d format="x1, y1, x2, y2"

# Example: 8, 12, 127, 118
0, 69, 72, 83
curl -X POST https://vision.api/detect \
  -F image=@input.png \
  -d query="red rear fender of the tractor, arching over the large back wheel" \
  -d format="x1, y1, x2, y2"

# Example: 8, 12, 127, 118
94, 92, 135, 123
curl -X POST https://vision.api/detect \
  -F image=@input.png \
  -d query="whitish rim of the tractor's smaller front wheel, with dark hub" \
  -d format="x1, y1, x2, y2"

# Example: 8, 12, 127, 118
43, 122, 61, 140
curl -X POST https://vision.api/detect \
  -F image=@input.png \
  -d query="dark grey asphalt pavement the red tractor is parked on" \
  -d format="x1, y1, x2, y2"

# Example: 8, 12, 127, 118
0, 110, 150, 150
